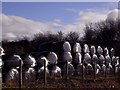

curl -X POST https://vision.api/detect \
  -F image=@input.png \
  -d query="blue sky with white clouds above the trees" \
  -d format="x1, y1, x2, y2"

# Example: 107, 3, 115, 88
0, 2, 118, 40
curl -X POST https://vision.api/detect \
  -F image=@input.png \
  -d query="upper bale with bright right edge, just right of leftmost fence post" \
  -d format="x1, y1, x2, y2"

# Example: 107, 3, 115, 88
23, 55, 36, 67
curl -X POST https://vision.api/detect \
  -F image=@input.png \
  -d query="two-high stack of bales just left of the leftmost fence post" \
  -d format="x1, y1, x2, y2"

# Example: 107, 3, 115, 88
2, 55, 23, 82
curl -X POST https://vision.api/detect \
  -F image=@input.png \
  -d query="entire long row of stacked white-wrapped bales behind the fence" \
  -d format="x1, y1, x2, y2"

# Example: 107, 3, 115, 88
0, 41, 120, 83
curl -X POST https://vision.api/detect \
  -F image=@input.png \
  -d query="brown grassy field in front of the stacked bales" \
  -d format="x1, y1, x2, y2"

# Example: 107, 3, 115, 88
3, 75, 120, 90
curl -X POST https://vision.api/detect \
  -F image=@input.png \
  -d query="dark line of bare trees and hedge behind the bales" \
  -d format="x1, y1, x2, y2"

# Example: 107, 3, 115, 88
1, 20, 120, 56
